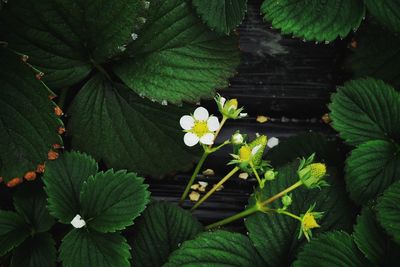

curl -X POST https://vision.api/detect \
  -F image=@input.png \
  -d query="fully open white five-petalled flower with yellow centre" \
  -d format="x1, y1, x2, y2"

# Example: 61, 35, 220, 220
179, 107, 220, 146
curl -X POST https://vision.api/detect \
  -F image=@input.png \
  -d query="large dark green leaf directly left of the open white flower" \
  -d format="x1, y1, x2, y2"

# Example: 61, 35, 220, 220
68, 75, 198, 176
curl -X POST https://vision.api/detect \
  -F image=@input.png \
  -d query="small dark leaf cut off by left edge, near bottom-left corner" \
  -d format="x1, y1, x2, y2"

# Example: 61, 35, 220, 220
0, 210, 30, 257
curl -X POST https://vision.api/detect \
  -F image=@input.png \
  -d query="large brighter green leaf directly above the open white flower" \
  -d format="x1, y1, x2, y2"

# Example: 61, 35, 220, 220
114, 0, 239, 104
